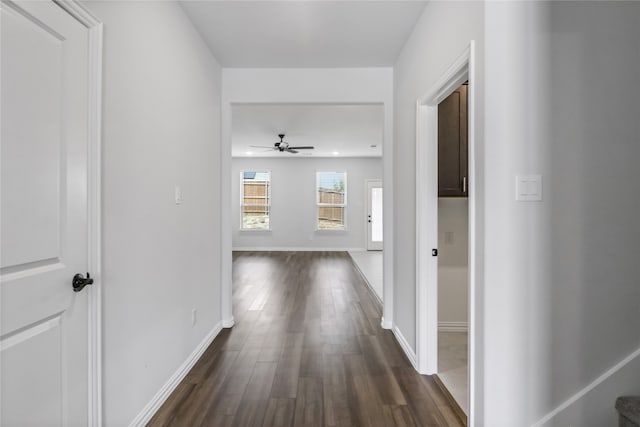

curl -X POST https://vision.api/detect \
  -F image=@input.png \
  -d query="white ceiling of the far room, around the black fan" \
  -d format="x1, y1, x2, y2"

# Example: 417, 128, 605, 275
231, 104, 384, 158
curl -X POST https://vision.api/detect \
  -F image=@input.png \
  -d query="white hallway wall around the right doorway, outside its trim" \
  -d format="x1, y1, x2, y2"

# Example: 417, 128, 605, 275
393, 1, 484, 417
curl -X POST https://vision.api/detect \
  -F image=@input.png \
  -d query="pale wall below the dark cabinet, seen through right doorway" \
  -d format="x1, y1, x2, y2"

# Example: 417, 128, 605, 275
438, 197, 469, 326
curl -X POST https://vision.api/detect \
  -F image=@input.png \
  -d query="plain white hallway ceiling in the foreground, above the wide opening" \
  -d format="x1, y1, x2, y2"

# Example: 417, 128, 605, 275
181, 0, 426, 68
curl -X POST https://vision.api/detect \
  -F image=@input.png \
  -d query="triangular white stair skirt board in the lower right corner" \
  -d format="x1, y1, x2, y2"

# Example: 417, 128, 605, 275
533, 348, 640, 427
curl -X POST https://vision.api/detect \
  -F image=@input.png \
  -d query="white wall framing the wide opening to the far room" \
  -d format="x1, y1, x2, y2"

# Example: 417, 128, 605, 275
221, 68, 394, 328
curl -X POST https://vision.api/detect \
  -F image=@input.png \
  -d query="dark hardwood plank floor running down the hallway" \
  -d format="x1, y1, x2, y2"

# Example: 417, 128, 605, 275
148, 252, 462, 427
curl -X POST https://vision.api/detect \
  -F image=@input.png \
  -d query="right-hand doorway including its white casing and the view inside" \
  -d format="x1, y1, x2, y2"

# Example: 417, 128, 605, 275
416, 41, 476, 425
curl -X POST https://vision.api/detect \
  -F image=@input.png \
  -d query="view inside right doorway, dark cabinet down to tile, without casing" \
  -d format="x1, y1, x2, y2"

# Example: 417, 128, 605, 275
437, 82, 469, 416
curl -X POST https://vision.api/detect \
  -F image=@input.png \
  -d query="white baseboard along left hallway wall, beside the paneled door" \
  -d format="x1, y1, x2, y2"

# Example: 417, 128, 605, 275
129, 322, 222, 427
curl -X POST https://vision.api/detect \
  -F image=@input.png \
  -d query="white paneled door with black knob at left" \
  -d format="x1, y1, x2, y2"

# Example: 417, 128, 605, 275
0, 1, 89, 426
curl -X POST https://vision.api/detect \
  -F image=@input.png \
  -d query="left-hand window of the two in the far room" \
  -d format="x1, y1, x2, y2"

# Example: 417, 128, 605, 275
240, 171, 271, 230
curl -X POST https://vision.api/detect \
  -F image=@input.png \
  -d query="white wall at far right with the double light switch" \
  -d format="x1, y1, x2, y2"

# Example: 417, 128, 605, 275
484, 2, 640, 426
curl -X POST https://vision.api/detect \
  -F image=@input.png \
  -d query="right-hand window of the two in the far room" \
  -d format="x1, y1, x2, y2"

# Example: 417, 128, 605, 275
316, 172, 347, 230
